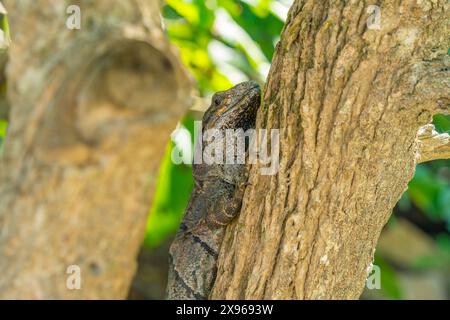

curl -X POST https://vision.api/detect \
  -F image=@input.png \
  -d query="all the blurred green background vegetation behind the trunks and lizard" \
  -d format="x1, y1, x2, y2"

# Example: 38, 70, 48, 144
0, 0, 450, 299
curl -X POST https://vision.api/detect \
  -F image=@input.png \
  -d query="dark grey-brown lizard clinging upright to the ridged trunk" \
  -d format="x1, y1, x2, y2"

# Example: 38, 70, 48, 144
167, 81, 261, 300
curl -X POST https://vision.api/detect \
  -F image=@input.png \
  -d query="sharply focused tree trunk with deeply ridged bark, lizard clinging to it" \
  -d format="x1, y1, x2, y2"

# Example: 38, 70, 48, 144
212, 0, 450, 299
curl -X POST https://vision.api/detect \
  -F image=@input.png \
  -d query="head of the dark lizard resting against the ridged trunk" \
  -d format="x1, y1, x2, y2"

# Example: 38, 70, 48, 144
203, 81, 261, 131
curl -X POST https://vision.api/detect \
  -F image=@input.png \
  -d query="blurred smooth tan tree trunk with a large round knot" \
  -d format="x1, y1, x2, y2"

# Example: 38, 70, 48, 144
0, 0, 191, 299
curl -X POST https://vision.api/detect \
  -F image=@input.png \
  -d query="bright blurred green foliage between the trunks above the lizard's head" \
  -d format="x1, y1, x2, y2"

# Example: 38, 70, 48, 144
163, 0, 287, 95
